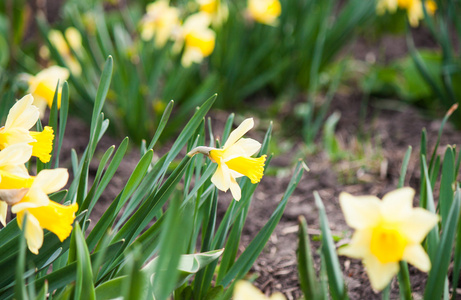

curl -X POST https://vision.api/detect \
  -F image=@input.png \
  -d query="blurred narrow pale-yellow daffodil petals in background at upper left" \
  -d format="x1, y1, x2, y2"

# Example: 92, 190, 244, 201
40, 27, 82, 75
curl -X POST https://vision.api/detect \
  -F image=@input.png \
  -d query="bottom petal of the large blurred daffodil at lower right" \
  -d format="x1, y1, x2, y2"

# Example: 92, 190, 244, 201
363, 255, 399, 291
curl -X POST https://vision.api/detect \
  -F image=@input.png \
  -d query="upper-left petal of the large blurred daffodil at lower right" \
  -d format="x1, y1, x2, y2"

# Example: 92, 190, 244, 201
339, 192, 381, 229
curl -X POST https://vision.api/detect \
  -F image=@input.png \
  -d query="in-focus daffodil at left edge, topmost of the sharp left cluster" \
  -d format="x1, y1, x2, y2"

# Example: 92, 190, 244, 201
0, 94, 54, 163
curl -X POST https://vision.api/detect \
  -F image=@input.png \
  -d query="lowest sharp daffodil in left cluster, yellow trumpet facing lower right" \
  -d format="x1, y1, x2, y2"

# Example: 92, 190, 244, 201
11, 169, 78, 254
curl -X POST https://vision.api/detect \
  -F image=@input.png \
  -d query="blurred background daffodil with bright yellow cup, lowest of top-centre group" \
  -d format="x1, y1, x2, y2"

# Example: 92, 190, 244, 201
181, 12, 216, 67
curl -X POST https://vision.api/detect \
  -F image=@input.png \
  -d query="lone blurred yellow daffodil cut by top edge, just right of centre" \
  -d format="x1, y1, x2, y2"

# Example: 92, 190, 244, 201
247, 0, 282, 26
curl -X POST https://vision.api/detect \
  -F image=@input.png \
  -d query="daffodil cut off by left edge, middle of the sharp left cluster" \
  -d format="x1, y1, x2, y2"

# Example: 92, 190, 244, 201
0, 143, 34, 226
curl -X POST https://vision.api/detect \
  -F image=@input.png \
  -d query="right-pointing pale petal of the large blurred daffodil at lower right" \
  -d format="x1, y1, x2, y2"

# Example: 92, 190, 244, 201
399, 207, 439, 244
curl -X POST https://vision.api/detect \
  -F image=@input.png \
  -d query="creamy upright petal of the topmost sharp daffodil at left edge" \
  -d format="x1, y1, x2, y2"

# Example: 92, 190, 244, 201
5, 94, 39, 130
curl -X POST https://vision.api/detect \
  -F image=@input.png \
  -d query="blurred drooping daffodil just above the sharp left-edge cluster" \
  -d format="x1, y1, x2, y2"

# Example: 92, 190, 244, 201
26, 66, 69, 117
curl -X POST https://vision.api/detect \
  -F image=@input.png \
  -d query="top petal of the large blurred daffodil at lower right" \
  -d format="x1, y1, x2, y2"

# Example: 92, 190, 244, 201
381, 187, 415, 221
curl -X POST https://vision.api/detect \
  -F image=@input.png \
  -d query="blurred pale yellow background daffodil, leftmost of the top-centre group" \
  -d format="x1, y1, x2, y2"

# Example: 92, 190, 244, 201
140, 0, 180, 48
